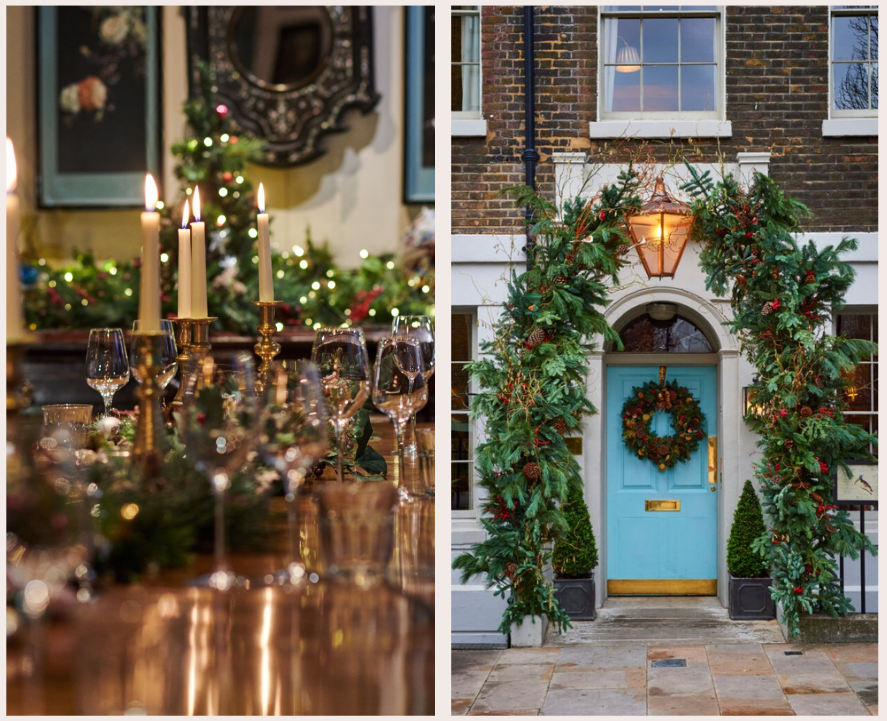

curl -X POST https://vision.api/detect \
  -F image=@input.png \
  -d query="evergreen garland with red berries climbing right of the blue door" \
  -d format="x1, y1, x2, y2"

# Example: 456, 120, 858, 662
685, 165, 877, 635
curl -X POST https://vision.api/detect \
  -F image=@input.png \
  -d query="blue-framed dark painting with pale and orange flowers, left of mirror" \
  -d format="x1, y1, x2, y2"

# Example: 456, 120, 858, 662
37, 5, 161, 208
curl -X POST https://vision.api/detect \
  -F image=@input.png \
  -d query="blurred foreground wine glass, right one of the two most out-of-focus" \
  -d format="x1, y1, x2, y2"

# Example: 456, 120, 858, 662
262, 361, 330, 584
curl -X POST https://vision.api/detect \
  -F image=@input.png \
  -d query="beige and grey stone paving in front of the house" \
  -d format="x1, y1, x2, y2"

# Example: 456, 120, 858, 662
452, 640, 878, 716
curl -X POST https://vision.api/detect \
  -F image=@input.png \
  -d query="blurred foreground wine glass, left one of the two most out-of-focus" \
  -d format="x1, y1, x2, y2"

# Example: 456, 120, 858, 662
179, 353, 260, 591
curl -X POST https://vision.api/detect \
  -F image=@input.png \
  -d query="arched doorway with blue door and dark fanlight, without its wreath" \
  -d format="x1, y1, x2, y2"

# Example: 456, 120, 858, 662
603, 302, 719, 595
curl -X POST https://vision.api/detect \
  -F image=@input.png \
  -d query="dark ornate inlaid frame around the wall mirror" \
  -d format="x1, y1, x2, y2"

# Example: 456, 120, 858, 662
185, 6, 380, 167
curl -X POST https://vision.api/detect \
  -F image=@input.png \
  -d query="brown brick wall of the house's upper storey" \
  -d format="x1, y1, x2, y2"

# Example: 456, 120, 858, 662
452, 7, 878, 233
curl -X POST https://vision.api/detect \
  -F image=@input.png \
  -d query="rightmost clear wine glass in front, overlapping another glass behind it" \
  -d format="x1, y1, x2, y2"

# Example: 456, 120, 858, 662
373, 337, 428, 488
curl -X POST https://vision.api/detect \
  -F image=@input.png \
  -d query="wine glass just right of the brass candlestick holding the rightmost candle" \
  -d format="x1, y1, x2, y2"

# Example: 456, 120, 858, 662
311, 328, 370, 482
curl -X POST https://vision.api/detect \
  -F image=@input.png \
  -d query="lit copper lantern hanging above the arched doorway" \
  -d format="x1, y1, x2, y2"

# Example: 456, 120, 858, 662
628, 177, 693, 278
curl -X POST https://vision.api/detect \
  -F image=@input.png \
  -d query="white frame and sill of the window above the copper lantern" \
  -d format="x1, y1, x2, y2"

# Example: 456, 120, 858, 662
589, 6, 733, 138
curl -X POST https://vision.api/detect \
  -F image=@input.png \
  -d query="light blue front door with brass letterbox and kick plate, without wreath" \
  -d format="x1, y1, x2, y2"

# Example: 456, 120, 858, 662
606, 366, 717, 595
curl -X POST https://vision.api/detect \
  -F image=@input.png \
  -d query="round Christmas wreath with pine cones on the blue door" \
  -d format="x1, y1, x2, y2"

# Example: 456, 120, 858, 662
622, 381, 705, 471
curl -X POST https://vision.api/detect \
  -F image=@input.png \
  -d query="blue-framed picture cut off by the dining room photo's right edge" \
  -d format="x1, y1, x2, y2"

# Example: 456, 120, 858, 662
403, 5, 434, 203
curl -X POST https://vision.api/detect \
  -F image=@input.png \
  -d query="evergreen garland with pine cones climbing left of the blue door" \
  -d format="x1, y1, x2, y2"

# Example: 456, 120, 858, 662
453, 169, 640, 634
